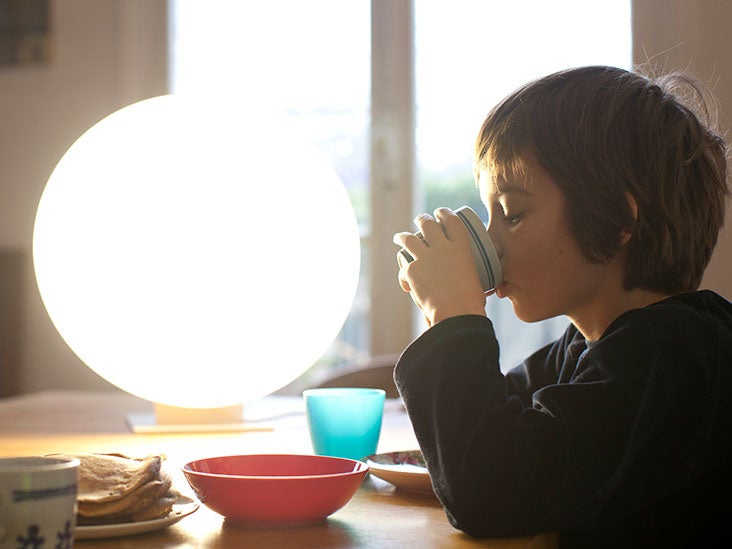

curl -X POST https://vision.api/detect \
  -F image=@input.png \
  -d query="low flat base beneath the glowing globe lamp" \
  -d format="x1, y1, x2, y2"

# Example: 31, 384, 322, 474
126, 403, 272, 434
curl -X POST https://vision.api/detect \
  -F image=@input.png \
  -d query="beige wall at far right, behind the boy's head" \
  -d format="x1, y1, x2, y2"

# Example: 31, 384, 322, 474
633, 0, 732, 299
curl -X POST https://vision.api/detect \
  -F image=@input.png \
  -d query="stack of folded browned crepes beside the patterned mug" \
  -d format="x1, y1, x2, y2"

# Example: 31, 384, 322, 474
57, 454, 180, 526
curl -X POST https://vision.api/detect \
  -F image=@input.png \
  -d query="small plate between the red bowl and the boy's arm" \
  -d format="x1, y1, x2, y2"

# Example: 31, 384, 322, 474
366, 450, 434, 494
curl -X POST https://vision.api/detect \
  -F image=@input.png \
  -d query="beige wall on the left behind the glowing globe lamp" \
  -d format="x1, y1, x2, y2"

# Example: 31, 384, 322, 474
0, 0, 167, 394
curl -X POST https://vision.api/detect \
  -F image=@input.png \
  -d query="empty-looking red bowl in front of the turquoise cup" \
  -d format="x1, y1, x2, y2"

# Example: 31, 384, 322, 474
183, 454, 369, 526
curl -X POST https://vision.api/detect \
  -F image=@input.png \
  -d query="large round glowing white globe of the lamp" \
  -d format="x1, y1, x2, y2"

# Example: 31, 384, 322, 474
33, 95, 360, 428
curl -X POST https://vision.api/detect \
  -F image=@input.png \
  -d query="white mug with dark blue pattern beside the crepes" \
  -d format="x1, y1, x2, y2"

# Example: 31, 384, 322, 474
0, 456, 79, 549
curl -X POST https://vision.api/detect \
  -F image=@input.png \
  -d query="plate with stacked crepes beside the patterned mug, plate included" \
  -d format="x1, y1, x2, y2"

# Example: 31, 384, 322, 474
49, 454, 199, 539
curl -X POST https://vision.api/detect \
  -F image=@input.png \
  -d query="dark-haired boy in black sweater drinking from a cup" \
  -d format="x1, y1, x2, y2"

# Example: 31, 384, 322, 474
394, 67, 732, 548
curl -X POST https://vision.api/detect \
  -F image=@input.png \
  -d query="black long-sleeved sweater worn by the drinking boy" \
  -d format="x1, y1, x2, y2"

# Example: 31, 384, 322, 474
395, 291, 732, 548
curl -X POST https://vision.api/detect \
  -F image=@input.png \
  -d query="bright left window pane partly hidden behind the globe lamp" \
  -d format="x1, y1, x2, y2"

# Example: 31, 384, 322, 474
170, 0, 370, 368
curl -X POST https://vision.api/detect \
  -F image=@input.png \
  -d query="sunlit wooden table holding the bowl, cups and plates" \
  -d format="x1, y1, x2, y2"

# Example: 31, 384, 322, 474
0, 391, 557, 549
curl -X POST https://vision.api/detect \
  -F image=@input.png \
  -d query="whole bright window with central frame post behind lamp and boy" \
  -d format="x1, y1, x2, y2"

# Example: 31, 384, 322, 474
170, 0, 631, 369
